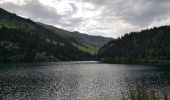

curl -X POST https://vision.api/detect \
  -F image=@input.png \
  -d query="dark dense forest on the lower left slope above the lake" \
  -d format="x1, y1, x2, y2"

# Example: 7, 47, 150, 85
0, 27, 92, 62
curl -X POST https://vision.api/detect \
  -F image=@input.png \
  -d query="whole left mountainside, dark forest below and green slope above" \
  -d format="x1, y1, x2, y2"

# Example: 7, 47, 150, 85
0, 8, 110, 62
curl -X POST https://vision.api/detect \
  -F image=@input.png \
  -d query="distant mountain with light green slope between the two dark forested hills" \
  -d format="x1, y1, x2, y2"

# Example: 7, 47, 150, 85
38, 23, 112, 55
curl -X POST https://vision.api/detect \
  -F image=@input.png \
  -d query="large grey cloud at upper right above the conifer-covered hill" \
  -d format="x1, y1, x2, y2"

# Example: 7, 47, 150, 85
79, 0, 170, 27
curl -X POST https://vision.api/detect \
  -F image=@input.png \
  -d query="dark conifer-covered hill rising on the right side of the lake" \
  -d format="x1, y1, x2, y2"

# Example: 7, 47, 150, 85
98, 26, 170, 63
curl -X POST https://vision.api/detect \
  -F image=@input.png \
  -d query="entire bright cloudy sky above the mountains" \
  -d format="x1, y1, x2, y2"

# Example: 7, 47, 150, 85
0, 0, 170, 38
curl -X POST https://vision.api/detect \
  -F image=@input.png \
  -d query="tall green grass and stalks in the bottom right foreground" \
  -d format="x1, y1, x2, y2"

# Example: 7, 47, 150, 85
121, 75, 170, 100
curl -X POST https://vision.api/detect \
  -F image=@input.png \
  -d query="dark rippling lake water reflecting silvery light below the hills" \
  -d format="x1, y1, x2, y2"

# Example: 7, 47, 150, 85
0, 62, 170, 100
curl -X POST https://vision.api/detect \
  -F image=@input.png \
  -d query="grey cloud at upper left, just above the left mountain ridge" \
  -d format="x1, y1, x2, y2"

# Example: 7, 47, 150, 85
0, 0, 83, 27
